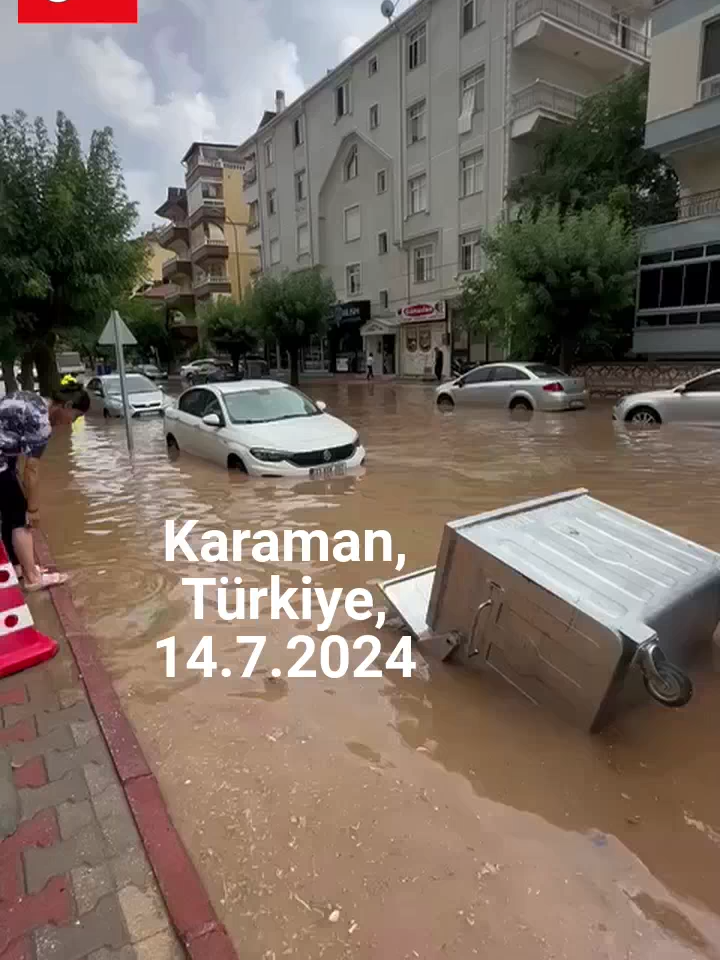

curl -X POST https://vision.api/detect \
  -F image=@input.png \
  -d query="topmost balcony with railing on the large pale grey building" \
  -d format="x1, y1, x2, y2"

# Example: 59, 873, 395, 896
513, 0, 650, 80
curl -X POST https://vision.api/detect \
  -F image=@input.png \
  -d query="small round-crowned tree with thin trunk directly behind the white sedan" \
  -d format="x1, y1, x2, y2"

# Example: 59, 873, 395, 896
250, 267, 337, 386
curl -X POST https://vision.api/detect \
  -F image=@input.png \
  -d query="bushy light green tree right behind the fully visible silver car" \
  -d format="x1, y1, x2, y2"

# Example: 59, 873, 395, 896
461, 206, 638, 370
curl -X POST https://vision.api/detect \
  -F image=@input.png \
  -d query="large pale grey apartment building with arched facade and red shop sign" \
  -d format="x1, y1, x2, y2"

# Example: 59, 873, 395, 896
239, 0, 649, 376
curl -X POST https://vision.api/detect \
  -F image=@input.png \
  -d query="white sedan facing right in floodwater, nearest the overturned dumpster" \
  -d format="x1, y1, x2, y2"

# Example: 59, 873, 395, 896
165, 380, 365, 477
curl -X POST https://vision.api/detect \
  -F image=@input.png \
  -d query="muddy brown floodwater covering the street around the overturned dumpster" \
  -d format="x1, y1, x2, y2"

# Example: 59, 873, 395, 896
38, 383, 720, 960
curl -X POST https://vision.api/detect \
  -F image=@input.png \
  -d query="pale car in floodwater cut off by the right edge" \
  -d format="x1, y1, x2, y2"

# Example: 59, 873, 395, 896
613, 369, 720, 427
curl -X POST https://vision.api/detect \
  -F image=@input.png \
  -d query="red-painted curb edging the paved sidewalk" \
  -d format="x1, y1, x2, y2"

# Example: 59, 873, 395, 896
35, 532, 239, 960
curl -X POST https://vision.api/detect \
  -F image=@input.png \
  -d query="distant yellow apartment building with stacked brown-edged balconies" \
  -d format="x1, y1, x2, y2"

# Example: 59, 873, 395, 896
156, 143, 258, 340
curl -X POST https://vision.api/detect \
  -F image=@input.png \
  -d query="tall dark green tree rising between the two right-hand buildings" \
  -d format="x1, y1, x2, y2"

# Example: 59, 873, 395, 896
508, 70, 678, 227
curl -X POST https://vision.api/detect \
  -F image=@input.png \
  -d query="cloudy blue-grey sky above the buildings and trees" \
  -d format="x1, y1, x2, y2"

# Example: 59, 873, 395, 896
0, 0, 400, 228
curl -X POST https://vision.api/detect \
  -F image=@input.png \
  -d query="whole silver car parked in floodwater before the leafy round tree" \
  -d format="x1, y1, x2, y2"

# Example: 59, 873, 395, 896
435, 363, 588, 410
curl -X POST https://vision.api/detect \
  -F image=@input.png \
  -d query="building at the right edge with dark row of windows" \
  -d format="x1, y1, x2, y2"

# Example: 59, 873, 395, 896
633, 0, 720, 359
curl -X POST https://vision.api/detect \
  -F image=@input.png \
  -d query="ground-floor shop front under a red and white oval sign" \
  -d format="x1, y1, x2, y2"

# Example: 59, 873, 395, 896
398, 300, 450, 379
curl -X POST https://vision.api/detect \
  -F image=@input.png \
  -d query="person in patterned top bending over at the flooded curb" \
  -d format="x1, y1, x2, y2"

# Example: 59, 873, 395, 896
0, 378, 90, 592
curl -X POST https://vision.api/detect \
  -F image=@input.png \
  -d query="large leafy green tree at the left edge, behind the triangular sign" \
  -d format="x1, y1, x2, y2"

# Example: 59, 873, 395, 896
0, 112, 147, 393
